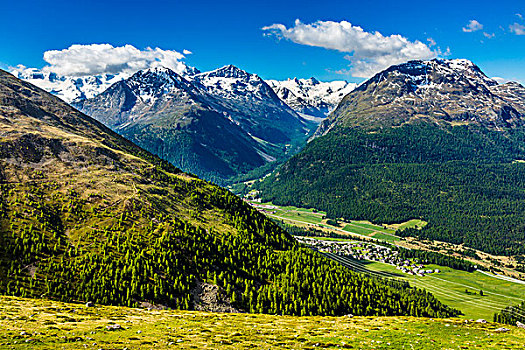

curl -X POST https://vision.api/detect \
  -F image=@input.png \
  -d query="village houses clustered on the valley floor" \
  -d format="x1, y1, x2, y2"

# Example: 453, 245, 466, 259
295, 236, 440, 276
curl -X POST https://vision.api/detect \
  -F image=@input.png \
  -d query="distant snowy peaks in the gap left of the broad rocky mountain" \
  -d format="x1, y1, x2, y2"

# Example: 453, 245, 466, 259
266, 78, 357, 122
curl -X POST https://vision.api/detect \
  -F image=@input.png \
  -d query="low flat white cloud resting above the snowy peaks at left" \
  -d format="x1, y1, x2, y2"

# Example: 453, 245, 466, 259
37, 44, 186, 76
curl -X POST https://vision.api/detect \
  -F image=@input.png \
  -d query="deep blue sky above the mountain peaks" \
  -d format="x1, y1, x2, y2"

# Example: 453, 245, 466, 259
0, 0, 525, 82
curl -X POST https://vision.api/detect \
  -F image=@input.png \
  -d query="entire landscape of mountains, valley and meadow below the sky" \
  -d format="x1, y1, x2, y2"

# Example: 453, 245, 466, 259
4, 54, 525, 349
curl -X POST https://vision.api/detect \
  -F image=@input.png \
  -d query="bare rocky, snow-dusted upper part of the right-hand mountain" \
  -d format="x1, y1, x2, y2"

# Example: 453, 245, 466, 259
316, 59, 525, 136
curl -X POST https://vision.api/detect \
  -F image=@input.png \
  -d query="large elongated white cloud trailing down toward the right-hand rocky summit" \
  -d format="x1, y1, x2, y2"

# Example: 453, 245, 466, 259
262, 20, 440, 78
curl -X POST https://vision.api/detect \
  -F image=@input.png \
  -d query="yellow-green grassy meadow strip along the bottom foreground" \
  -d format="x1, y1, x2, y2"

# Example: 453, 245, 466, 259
0, 297, 525, 350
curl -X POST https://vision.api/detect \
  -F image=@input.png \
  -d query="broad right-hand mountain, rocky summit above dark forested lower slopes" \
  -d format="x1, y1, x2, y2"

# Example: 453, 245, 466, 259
259, 60, 525, 255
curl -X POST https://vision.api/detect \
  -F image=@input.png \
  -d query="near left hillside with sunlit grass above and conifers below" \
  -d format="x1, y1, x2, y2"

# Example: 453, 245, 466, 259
0, 71, 457, 317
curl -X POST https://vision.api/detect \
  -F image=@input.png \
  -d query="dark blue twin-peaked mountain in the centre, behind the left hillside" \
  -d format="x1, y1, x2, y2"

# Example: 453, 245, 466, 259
78, 66, 313, 183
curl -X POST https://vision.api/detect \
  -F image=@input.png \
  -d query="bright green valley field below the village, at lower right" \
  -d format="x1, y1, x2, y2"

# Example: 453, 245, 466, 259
326, 253, 525, 320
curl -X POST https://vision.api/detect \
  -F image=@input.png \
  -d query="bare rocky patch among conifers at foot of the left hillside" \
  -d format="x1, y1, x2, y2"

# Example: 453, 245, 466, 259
191, 281, 241, 312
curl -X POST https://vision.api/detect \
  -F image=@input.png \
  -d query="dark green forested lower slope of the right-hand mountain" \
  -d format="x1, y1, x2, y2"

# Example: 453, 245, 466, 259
256, 122, 525, 255
